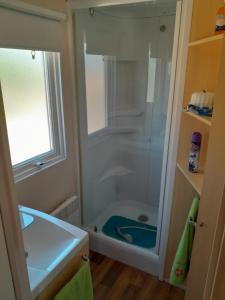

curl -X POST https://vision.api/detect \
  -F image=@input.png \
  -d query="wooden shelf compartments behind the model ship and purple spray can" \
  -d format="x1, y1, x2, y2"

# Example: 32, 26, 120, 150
177, 29, 225, 188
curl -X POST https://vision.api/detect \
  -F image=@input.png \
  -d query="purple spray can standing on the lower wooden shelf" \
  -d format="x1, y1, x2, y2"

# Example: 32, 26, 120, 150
189, 132, 202, 173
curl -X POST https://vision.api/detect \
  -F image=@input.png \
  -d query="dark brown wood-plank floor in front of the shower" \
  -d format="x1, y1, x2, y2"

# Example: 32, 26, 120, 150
90, 252, 184, 300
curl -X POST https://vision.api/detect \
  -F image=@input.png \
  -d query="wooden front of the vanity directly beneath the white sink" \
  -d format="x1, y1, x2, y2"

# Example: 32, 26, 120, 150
35, 243, 89, 300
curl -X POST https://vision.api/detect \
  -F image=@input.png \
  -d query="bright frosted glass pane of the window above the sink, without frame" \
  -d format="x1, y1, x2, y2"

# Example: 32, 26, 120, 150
0, 49, 52, 165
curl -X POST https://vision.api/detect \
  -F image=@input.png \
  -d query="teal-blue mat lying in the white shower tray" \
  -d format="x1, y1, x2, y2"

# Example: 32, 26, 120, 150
102, 216, 157, 249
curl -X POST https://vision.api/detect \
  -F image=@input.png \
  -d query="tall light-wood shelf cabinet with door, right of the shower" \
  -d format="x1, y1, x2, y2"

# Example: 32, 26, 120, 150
165, 0, 225, 300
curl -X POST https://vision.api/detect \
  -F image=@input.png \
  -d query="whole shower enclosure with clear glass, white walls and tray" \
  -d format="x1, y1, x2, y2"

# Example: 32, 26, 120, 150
74, 1, 176, 274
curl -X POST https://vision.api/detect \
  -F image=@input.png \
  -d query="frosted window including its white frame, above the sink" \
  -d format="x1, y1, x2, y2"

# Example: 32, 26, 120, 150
0, 48, 65, 180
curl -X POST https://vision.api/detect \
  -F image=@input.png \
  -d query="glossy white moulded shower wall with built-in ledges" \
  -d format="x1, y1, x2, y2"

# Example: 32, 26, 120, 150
77, 5, 175, 225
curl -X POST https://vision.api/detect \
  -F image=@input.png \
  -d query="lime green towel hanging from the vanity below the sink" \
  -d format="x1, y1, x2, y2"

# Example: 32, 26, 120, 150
54, 261, 93, 300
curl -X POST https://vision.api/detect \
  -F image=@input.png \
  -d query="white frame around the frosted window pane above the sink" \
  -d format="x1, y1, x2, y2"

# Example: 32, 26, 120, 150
7, 52, 66, 182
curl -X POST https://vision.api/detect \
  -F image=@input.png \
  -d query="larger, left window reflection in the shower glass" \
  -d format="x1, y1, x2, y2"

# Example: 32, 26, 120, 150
85, 54, 107, 134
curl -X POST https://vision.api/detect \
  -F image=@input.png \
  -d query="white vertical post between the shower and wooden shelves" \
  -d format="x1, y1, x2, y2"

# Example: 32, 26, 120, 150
159, 0, 193, 280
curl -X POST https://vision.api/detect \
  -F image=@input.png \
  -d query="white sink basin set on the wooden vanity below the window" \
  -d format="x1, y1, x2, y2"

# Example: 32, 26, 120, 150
19, 206, 88, 298
